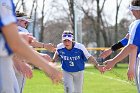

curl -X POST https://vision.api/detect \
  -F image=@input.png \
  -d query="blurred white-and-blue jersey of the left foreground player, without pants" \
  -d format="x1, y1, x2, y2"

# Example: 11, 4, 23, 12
0, 0, 16, 56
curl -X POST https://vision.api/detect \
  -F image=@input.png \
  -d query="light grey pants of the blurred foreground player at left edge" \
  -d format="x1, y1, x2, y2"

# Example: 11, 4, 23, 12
0, 56, 20, 93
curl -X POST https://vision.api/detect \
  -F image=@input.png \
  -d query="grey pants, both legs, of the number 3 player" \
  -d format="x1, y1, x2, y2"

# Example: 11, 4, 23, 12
63, 71, 84, 93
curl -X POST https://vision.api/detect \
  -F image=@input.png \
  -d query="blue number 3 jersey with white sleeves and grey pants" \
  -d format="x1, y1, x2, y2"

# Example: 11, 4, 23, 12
56, 42, 91, 93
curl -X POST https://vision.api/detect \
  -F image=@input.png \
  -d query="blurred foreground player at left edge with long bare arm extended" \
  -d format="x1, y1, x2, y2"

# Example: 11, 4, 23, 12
0, 0, 61, 93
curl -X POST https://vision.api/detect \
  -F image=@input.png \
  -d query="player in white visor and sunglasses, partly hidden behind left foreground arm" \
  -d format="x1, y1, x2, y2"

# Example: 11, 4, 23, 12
13, 11, 55, 93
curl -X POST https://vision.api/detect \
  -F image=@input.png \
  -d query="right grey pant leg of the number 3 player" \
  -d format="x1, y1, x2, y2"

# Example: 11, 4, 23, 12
73, 71, 84, 93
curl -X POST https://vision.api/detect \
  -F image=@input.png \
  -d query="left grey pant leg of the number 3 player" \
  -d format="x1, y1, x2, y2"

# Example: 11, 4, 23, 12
63, 71, 73, 93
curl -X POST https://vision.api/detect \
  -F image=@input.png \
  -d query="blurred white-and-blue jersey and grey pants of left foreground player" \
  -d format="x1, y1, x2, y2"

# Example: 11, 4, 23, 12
0, 0, 19, 93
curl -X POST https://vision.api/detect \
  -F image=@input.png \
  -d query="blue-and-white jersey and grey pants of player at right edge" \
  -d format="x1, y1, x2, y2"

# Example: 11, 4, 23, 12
128, 20, 140, 93
